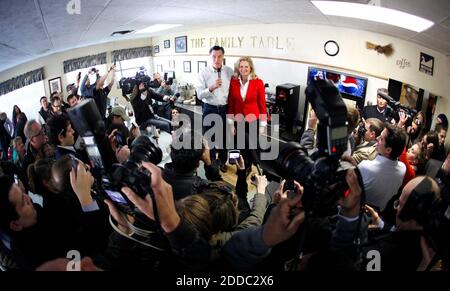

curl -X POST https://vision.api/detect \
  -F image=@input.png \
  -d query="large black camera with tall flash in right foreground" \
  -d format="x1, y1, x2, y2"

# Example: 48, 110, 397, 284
275, 80, 356, 217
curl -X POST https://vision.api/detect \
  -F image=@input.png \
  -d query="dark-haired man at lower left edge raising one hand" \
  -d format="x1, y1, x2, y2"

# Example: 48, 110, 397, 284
0, 161, 108, 270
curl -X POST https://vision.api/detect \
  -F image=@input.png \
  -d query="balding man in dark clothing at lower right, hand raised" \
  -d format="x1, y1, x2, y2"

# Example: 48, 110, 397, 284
333, 173, 443, 271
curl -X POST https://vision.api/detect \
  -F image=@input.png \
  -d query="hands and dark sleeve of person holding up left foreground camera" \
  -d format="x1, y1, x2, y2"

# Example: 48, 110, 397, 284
105, 163, 211, 271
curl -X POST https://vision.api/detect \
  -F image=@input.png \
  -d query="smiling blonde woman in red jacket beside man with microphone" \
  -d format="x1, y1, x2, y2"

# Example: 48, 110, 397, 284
228, 57, 267, 170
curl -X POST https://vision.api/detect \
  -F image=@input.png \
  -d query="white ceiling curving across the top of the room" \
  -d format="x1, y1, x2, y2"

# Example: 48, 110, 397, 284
0, 0, 450, 72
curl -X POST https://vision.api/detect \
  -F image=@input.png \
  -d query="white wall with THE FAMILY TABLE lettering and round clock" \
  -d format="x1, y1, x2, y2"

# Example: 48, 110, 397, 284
0, 24, 450, 146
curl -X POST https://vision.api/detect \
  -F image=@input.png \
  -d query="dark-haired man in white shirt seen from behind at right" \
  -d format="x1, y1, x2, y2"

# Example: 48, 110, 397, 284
358, 124, 406, 210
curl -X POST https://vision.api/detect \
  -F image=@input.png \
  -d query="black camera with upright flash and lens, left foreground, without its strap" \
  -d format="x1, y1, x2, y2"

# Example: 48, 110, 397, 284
68, 99, 162, 213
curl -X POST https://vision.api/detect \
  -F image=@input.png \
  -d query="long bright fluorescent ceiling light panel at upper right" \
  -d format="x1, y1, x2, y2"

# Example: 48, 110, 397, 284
311, 1, 434, 32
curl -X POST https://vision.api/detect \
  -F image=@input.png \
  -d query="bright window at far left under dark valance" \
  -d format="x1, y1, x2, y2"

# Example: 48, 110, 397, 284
0, 81, 45, 121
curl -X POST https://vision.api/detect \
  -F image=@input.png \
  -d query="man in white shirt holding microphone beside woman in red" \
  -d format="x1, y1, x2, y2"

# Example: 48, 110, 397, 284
196, 46, 233, 171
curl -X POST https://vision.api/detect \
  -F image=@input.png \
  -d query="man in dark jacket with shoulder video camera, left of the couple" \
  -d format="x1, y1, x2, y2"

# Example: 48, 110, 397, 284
130, 82, 171, 133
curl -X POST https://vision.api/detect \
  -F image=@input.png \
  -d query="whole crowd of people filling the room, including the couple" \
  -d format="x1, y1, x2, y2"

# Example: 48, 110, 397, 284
0, 46, 450, 271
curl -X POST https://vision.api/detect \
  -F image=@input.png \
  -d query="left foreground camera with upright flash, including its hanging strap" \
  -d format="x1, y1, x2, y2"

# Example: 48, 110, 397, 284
68, 99, 168, 250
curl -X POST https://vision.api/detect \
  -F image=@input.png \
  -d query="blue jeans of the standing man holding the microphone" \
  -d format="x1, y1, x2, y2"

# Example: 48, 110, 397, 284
202, 103, 228, 165
